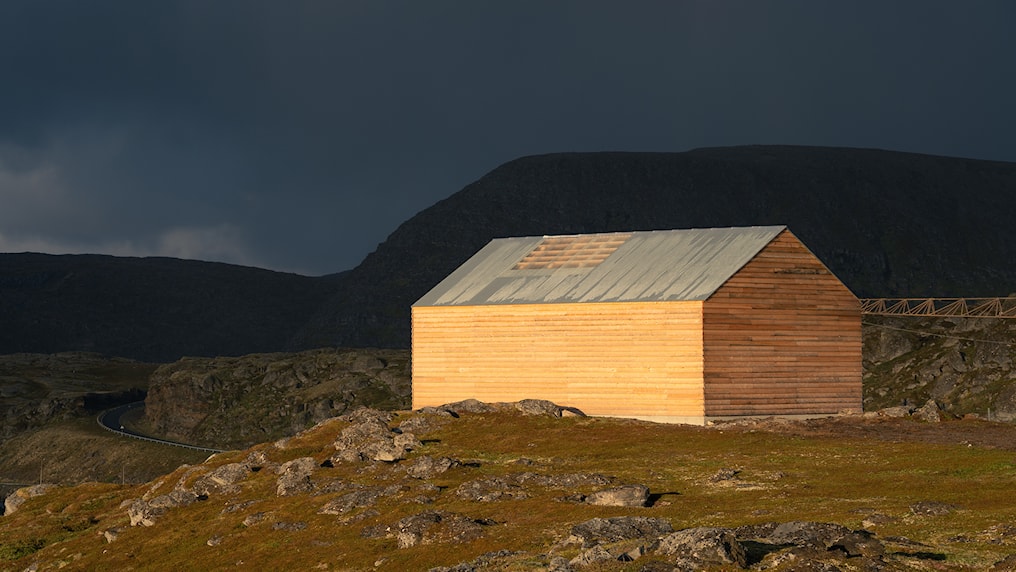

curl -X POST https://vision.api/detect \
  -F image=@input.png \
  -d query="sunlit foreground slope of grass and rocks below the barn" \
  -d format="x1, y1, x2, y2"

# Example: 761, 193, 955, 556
0, 401, 1016, 572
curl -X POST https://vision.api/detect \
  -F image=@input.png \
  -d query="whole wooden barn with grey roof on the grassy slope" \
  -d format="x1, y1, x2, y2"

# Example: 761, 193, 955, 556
412, 227, 861, 424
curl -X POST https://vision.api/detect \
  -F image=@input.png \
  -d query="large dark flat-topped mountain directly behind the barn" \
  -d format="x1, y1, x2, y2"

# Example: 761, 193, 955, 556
298, 146, 1016, 346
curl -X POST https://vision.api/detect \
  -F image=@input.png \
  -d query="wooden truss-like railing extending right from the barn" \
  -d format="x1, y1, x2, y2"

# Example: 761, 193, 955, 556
861, 297, 1016, 318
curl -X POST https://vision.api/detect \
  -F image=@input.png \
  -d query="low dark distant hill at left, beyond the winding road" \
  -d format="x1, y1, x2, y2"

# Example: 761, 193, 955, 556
0, 253, 336, 363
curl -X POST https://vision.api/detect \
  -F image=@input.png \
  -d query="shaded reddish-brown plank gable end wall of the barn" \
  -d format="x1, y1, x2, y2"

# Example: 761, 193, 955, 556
703, 231, 861, 417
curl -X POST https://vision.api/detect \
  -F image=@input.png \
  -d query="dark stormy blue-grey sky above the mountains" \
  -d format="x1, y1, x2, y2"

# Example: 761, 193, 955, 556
0, 0, 1016, 275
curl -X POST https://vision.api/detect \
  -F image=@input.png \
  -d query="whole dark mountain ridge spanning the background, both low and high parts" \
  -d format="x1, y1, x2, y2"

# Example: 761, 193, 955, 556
0, 146, 1016, 362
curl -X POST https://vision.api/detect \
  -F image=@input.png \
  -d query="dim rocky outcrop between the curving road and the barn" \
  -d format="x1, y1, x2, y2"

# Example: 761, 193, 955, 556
145, 349, 410, 449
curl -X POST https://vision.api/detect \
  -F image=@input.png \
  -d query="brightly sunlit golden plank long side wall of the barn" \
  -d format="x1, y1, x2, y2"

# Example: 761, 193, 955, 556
412, 302, 703, 420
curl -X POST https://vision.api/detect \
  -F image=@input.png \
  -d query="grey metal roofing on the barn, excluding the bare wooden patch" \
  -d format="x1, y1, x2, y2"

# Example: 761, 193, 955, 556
415, 226, 786, 306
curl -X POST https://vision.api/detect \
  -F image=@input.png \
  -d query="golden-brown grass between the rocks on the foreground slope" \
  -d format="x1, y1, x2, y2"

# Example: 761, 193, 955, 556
0, 414, 1016, 570
